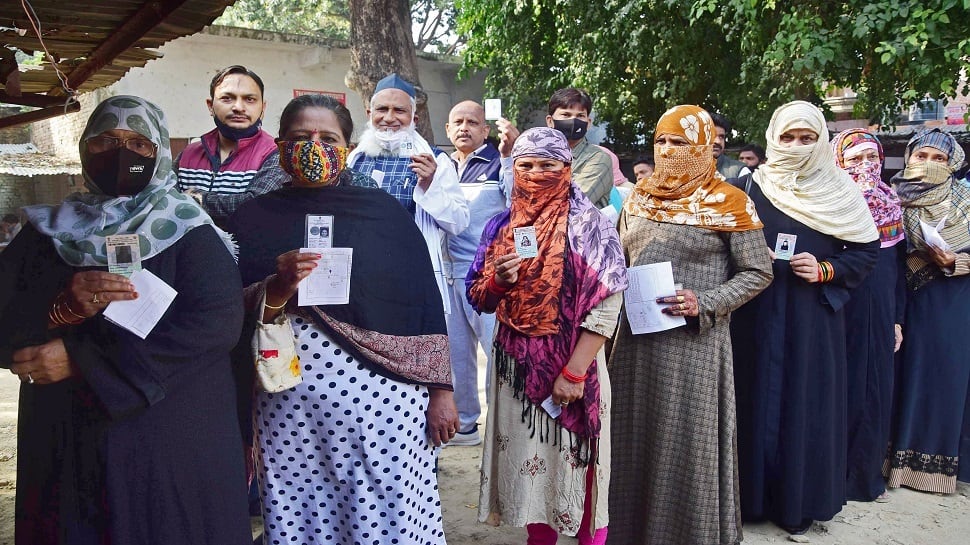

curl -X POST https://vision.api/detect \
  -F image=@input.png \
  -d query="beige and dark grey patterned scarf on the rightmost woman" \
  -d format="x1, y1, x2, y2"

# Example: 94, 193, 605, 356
892, 129, 970, 290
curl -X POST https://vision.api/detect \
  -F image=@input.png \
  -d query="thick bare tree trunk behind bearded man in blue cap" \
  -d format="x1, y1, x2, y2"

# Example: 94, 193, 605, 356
344, 0, 434, 145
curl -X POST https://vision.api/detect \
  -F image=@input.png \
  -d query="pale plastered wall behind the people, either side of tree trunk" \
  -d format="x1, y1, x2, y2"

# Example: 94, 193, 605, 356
33, 27, 484, 157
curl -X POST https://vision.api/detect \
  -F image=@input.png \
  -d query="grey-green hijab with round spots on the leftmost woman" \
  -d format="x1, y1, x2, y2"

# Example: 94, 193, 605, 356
24, 95, 235, 267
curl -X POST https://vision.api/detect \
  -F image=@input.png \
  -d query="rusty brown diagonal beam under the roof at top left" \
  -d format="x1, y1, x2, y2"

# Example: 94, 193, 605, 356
47, 0, 187, 96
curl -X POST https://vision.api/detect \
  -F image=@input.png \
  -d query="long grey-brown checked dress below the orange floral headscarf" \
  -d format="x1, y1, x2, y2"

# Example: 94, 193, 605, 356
608, 215, 771, 545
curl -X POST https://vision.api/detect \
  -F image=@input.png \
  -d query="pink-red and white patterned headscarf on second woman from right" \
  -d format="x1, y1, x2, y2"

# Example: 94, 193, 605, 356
832, 129, 905, 248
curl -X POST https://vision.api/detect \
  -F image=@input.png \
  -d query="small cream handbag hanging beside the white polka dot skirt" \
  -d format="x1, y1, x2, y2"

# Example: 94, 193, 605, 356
253, 289, 303, 393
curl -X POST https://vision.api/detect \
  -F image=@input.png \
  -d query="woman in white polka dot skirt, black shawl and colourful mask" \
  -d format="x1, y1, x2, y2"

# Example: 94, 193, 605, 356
230, 96, 458, 545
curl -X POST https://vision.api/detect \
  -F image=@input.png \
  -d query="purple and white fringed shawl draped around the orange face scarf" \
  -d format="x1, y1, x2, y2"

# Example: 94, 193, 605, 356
466, 183, 627, 446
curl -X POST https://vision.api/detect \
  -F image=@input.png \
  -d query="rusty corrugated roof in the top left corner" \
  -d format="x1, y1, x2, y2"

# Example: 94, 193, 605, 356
0, 0, 235, 125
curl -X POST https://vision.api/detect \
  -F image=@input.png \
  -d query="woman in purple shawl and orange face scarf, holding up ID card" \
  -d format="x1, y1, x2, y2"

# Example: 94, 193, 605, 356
466, 127, 627, 545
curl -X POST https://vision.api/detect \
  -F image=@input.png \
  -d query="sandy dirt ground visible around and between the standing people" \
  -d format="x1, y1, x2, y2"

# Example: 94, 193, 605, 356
0, 360, 970, 545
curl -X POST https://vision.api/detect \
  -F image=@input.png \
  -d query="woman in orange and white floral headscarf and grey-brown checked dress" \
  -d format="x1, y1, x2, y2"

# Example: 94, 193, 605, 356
609, 106, 772, 545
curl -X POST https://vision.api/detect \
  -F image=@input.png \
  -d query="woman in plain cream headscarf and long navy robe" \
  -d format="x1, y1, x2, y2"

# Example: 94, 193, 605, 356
732, 101, 879, 534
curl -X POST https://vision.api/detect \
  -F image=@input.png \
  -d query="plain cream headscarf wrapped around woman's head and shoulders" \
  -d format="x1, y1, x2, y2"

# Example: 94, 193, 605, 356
752, 100, 879, 242
